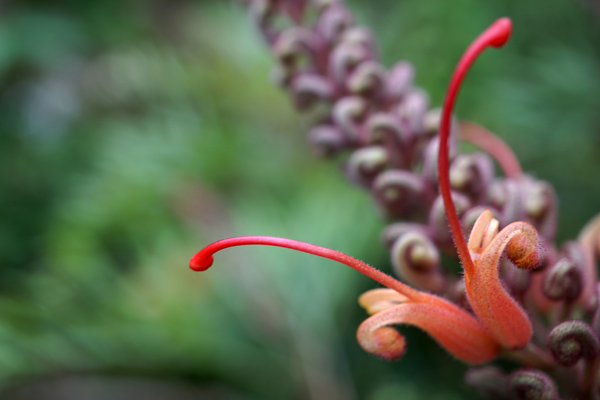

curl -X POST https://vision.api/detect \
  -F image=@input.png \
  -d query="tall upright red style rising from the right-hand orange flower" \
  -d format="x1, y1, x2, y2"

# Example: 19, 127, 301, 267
438, 18, 512, 271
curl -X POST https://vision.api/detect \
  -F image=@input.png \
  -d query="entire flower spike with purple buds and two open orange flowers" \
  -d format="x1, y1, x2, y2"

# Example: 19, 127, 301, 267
190, 0, 600, 399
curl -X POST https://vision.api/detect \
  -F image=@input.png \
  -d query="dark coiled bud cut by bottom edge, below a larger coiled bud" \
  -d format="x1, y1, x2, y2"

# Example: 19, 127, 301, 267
508, 369, 558, 400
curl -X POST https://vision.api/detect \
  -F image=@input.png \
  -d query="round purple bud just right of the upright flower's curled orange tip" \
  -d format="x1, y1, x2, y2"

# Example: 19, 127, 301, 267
542, 257, 583, 302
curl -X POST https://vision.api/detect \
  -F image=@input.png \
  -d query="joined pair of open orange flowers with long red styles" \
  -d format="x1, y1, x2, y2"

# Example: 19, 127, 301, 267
190, 18, 542, 364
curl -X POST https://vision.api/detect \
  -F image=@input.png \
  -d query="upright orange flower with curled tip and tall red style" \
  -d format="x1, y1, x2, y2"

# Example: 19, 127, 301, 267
438, 18, 543, 349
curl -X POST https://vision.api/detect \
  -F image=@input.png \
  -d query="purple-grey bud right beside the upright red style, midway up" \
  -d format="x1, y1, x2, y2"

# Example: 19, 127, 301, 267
450, 153, 494, 202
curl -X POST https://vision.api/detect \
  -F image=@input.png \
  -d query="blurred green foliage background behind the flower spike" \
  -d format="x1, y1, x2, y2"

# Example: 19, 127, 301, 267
0, 0, 600, 400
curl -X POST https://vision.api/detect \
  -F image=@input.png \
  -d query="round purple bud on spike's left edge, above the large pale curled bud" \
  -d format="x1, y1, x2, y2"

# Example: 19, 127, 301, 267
373, 169, 426, 217
